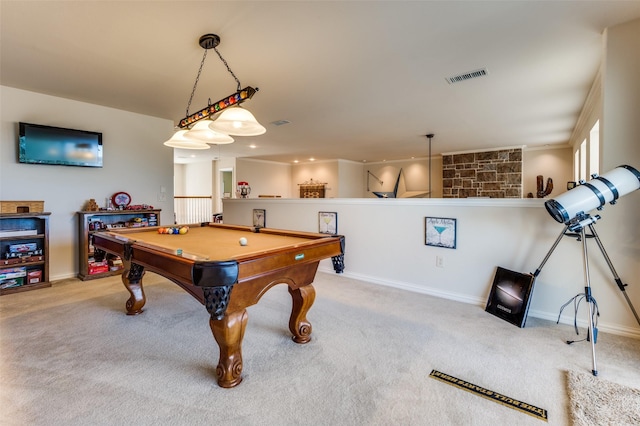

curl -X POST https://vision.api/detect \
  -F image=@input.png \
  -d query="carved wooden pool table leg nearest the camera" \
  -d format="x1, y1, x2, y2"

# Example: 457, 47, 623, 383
209, 309, 248, 388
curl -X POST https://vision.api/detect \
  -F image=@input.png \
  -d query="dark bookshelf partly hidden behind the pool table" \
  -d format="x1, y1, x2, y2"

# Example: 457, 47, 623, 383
77, 209, 160, 281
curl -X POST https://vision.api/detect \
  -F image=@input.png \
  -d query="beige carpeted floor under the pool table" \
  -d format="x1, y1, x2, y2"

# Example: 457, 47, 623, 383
0, 272, 640, 426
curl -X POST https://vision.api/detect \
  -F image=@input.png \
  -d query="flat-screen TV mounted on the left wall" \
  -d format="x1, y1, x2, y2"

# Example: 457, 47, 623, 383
18, 123, 102, 167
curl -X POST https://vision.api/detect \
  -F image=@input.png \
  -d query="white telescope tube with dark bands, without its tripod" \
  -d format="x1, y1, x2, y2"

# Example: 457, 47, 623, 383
544, 165, 640, 224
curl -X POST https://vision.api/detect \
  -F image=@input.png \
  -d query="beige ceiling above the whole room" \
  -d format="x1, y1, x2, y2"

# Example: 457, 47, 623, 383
0, 0, 640, 162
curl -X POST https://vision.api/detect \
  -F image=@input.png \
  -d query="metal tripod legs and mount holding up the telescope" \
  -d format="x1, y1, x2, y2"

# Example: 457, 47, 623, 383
533, 214, 640, 376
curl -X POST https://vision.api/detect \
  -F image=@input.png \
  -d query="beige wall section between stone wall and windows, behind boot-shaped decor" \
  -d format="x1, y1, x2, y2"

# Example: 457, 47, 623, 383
522, 146, 573, 198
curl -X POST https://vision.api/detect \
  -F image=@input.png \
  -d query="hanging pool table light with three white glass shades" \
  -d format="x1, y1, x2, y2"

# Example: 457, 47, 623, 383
164, 34, 267, 149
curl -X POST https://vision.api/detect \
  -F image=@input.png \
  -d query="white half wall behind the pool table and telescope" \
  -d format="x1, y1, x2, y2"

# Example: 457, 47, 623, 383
224, 198, 640, 337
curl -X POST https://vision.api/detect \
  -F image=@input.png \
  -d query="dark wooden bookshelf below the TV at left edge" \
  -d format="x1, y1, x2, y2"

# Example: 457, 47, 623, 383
0, 213, 51, 295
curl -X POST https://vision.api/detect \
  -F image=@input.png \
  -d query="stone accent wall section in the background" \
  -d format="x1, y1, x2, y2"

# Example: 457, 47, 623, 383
442, 148, 522, 198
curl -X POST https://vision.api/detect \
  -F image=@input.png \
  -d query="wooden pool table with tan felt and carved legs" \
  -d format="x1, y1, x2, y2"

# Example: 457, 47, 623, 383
93, 223, 345, 388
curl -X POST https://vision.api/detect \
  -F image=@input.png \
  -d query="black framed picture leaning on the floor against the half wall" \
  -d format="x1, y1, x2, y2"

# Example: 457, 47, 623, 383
485, 266, 534, 328
